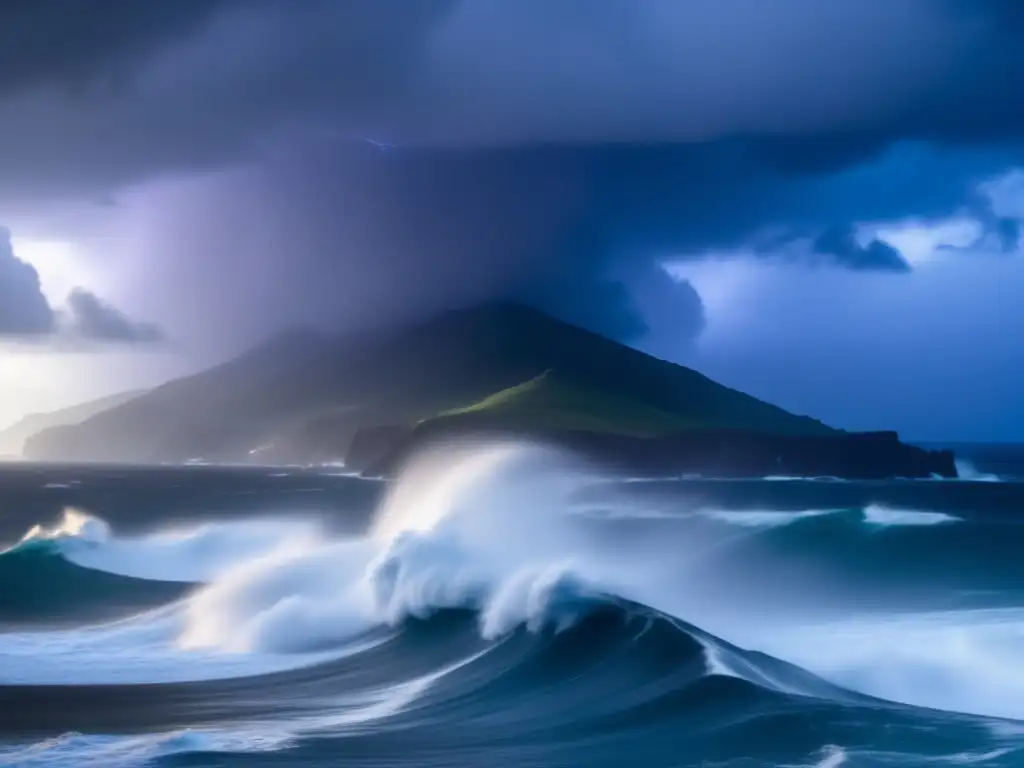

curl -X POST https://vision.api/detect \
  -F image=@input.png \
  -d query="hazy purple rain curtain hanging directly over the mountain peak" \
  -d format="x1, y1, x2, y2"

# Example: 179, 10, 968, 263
119, 142, 698, 338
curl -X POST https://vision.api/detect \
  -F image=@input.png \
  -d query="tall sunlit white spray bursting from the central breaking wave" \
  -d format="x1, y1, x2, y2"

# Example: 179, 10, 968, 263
181, 442, 630, 652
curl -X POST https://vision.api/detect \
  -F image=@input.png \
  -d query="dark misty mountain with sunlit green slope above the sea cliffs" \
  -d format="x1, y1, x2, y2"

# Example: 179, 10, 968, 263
27, 303, 950, 479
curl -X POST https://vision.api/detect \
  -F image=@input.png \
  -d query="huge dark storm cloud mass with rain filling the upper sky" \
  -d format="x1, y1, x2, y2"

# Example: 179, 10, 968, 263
6, 0, 1024, 348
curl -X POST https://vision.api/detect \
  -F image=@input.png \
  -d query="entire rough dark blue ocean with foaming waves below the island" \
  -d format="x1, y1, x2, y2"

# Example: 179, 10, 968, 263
0, 445, 1024, 768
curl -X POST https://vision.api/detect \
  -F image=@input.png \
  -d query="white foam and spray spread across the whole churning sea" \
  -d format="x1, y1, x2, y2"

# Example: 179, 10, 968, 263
6, 443, 1024, 729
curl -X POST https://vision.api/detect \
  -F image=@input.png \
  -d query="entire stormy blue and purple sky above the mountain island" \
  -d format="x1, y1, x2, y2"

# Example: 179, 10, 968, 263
0, 0, 1024, 440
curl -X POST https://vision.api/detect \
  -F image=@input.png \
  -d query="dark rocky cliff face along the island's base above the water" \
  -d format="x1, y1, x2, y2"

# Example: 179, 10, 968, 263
345, 418, 956, 479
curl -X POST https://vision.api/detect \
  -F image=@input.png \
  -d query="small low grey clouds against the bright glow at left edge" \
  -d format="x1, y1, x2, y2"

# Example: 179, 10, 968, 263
0, 227, 163, 343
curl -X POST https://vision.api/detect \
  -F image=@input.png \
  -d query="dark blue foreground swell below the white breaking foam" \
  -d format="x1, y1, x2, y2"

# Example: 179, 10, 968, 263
0, 596, 1012, 767
